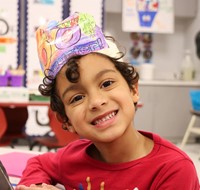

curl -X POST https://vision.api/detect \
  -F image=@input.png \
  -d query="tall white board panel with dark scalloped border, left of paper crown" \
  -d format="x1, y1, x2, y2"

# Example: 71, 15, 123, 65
26, 0, 64, 90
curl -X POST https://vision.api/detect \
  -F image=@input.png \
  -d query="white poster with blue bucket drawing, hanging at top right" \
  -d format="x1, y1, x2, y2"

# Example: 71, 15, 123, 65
122, 0, 174, 33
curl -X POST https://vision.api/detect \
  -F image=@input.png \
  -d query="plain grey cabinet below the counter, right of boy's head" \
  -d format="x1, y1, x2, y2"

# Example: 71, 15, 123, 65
135, 82, 199, 141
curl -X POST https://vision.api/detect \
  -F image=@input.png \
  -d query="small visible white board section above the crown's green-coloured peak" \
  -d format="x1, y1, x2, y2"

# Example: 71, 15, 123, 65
69, 0, 104, 29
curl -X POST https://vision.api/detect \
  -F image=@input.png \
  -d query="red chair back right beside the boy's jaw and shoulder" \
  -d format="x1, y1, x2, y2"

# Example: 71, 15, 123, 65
48, 109, 80, 147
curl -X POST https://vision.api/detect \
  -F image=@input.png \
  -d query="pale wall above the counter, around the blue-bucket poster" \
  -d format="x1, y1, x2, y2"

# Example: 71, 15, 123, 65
105, 3, 200, 79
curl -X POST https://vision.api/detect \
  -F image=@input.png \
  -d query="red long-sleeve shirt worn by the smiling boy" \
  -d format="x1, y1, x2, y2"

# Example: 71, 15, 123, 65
20, 132, 200, 190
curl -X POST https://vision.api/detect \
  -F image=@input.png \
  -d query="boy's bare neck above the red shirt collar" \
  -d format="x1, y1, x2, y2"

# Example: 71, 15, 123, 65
88, 128, 153, 163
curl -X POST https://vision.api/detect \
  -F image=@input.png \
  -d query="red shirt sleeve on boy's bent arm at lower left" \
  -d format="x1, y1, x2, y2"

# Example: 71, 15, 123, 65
19, 150, 62, 186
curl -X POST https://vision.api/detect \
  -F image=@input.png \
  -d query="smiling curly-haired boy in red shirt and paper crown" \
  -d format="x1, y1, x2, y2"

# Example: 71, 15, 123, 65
17, 13, 199, 190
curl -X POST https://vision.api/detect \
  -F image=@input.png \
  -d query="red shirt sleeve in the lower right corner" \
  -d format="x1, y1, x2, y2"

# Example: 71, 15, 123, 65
153, 159, 200, 190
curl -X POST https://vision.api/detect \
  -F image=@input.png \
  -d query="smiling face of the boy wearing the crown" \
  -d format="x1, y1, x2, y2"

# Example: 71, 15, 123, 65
56, 54, 138, 142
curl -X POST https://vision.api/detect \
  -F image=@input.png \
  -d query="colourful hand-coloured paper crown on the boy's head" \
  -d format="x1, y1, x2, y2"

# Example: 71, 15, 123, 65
36, 13, 122, 78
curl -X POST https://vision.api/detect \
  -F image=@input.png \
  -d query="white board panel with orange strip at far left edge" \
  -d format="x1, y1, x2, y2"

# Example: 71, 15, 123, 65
0, 0, 20, 75
